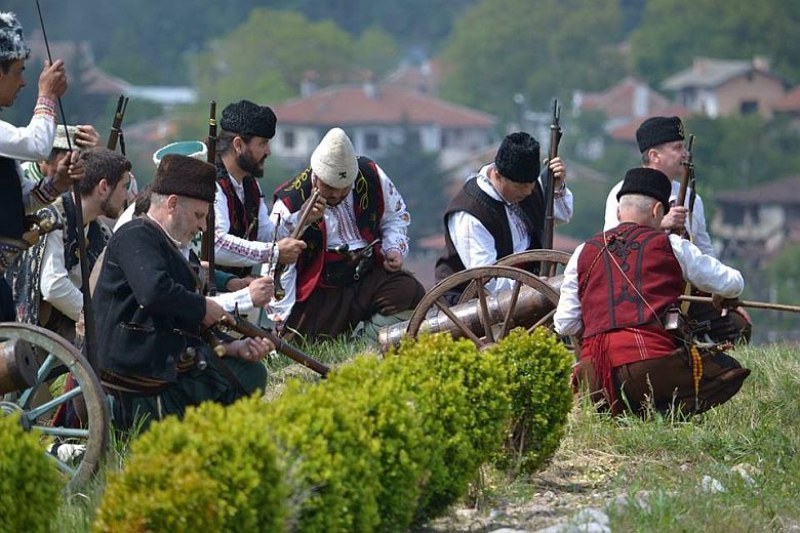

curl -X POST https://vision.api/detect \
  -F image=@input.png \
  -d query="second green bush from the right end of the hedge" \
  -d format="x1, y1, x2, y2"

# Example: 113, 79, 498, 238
385, 334, 510, 521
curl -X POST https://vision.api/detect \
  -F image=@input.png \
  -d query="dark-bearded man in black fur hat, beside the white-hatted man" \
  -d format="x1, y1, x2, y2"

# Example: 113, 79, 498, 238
214, 100, 306, 277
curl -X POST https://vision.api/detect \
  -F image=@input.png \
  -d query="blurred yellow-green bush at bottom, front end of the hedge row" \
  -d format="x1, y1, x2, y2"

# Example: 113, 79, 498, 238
95, 398, 288, 532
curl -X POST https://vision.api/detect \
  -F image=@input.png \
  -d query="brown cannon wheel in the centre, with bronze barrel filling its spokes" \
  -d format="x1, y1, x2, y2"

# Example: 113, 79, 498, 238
406, 265, 558, 348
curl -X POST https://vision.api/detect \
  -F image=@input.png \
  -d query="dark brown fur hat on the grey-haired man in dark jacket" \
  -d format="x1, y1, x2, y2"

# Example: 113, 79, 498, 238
151, 154, 217, 203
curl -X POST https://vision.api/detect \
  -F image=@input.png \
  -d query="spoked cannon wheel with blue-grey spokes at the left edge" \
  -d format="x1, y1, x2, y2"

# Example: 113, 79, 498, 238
0, 323, 109, 492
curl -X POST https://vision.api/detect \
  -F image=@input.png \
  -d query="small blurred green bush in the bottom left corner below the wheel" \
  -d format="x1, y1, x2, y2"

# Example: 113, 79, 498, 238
0, 412, 64, 533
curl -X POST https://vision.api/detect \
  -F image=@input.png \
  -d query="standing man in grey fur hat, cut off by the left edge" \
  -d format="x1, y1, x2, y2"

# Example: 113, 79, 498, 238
0, 12, 83, 321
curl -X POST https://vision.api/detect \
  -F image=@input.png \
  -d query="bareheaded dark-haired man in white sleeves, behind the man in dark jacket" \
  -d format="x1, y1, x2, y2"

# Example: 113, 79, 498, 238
14, 148, 131, 341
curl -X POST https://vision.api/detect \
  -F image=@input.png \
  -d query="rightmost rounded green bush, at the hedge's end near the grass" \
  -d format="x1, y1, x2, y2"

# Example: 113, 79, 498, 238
487, 328, 574, 475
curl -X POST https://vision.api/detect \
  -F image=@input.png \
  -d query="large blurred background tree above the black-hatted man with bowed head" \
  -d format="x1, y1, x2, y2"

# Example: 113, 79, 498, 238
442, 0, 624, 121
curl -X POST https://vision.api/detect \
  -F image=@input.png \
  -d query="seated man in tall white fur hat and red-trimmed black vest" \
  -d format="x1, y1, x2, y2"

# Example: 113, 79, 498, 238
270, 128, 425, 338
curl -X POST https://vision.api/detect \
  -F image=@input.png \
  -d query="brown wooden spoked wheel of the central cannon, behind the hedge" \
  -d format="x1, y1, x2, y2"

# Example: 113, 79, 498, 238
406, 265, 558, 348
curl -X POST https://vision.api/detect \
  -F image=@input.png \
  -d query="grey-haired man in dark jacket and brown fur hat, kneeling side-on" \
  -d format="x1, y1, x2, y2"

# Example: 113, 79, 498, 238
94, 154, 275, 428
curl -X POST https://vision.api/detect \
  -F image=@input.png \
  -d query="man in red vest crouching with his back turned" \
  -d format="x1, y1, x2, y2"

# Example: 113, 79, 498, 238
554, 168, 750, 415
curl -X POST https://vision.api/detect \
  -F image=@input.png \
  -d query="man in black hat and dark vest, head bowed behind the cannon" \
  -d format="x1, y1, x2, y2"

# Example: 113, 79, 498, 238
436, 132, 572, 301
